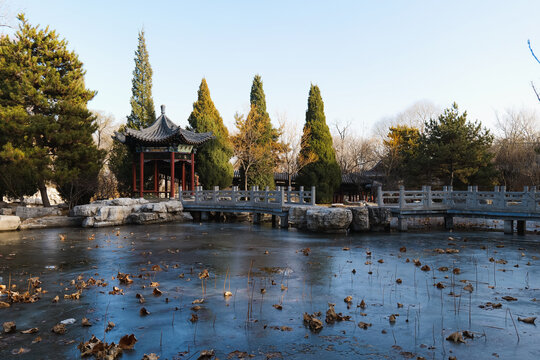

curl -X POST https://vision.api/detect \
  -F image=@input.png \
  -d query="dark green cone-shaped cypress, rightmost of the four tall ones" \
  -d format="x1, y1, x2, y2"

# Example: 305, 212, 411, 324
296, 84, 341, 203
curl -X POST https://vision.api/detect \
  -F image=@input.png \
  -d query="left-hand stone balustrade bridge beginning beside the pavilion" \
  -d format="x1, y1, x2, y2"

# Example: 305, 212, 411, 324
178, 186, 315, 228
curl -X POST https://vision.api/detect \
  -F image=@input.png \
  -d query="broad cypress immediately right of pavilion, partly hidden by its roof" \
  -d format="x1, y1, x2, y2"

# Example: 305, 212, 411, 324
188, 78, 233, 189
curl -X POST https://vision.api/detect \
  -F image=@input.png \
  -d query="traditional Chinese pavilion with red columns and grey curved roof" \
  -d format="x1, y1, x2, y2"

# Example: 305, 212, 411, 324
114, 105, 214, 198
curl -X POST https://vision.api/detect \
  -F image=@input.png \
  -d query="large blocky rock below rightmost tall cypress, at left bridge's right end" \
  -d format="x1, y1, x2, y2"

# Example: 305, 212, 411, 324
306, 207, 352, 233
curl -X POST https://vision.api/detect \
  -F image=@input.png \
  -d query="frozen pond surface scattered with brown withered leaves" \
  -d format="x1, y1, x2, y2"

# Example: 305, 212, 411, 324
0, 223, 540, 359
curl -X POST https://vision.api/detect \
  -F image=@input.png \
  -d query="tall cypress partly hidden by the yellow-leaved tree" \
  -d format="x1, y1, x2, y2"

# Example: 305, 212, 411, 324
244, 75, 279, 188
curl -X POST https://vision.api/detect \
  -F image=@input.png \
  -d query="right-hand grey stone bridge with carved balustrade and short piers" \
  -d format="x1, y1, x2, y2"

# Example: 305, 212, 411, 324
377, 186, 540, 234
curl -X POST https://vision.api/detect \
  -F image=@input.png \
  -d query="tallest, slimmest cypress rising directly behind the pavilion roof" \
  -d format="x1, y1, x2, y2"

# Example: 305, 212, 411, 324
127, 30, 156, 129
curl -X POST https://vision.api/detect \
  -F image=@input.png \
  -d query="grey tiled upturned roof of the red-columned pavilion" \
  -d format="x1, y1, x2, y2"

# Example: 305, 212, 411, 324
114, 105, 214, 145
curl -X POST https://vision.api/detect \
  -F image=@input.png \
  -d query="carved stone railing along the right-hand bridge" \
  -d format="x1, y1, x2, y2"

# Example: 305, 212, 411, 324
377, 186, 540, 213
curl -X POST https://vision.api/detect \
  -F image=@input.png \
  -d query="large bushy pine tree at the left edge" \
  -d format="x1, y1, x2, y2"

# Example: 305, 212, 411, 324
0, 14, 103, 206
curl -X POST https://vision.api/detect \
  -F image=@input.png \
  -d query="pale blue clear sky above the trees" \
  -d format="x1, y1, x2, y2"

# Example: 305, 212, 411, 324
3, 0, 540, 135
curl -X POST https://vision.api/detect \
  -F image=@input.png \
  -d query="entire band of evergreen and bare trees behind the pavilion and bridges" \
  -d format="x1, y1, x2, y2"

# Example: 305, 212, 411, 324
0, 15, 540, 206
